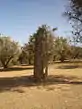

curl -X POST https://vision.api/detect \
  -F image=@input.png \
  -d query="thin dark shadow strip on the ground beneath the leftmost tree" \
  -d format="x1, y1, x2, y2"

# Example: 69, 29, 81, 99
0, 66, 33, 72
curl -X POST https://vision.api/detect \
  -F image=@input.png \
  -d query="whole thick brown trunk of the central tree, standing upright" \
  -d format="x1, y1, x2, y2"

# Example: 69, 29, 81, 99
34, 26, 49, 82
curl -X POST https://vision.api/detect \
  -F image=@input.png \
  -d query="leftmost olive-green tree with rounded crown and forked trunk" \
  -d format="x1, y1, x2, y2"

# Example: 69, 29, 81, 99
0, 36, 20, 68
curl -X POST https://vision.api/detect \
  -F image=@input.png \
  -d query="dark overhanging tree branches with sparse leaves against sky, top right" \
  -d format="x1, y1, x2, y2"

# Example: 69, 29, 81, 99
65, 0, 82, 42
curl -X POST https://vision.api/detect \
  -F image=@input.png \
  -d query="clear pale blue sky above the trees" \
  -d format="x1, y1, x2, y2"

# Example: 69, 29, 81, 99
0, 0, 71, 44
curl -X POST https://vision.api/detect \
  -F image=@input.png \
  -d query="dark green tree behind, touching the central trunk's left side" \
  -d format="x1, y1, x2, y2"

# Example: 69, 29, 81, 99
19, 34, 35, 65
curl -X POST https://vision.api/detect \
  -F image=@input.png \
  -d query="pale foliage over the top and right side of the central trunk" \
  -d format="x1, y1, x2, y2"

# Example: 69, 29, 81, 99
36, 25, 57, 61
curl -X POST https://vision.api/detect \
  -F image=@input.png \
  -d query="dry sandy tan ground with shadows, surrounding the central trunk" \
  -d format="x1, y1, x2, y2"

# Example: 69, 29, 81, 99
0, 63, 82, 109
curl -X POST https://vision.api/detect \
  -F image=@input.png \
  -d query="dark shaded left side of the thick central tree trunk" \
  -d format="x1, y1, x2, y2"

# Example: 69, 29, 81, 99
34, 37, 43, 81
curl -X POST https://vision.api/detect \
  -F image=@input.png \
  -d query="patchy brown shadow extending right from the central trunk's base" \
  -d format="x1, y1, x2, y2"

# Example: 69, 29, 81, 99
47, 75, 82, 85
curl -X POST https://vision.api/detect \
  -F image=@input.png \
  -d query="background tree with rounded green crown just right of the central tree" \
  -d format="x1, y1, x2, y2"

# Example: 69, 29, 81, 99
54, 37, 71, 62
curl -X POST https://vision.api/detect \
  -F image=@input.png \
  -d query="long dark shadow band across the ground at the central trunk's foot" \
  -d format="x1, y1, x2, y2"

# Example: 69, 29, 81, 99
0, 75, 82, 93
